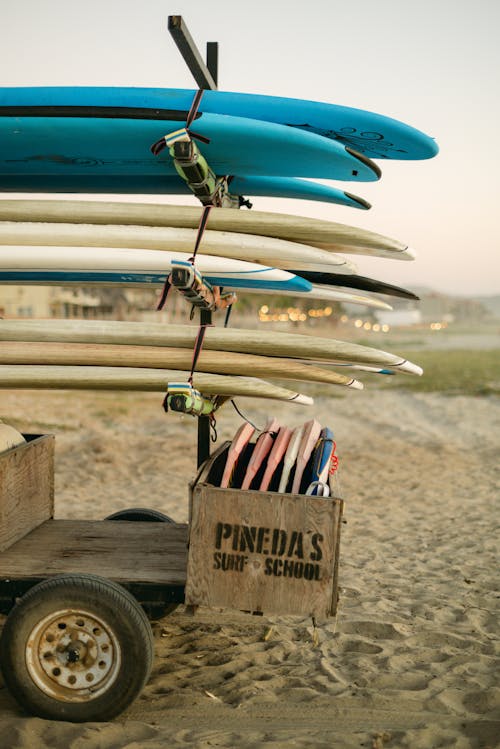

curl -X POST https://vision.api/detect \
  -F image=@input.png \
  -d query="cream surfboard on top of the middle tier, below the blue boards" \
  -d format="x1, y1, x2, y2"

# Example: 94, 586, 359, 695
0, 199, 415, 260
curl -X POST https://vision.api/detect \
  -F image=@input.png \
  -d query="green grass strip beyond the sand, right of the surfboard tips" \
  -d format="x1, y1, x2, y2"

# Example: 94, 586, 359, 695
376, 349, 500, 395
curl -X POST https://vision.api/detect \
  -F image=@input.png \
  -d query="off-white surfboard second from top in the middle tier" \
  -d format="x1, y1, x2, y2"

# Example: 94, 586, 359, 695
0, 221, 356, 273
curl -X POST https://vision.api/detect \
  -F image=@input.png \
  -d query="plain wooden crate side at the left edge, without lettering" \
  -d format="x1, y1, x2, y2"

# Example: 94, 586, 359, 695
0, 434, 54, 551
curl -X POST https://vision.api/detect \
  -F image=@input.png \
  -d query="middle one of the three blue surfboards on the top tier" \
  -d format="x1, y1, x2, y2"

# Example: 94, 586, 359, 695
0, 99, 380, 184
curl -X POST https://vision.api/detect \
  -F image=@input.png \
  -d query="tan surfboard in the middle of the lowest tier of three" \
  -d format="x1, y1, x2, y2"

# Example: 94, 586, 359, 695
0, 341, 363, 390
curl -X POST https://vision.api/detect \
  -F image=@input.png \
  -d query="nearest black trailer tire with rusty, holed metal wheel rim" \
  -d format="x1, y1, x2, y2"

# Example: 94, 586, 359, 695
0, 575, 154, 723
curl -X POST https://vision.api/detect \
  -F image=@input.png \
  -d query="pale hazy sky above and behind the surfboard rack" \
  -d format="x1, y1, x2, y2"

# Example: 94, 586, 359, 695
0, 0, 500, 296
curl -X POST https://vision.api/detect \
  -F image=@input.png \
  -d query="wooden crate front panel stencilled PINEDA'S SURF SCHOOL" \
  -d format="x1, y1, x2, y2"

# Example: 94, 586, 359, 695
186, 484, 343, 619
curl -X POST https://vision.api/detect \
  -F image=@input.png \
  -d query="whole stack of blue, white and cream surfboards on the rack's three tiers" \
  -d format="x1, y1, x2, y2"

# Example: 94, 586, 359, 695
0, 88, 437, 402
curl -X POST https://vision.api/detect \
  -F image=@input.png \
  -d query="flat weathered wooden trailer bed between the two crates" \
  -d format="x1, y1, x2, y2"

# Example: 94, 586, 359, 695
0, 520, 188, 585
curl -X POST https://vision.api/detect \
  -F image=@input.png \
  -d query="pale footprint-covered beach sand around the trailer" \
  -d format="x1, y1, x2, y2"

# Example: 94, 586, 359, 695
0, 382, 500, 749
